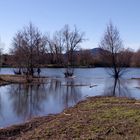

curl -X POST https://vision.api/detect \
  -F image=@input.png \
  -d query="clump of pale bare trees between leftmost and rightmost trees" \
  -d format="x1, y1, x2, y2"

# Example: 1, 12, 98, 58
47, 25, 84, 75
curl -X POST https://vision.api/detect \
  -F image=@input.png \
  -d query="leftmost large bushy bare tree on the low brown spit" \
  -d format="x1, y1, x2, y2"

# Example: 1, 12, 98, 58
12, 23, 46, 76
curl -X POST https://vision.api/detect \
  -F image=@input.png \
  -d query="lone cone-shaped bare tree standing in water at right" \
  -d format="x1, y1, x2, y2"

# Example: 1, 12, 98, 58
100, 23, 128, 79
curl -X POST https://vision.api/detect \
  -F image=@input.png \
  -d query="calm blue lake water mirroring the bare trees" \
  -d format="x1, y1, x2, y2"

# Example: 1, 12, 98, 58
0, 68, 140, 127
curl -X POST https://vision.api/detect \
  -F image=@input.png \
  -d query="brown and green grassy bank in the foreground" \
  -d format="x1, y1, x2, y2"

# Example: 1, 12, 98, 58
0, 97, 140, 140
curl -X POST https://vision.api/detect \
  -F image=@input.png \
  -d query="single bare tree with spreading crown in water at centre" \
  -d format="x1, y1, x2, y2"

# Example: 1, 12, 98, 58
62, 25, 84, 77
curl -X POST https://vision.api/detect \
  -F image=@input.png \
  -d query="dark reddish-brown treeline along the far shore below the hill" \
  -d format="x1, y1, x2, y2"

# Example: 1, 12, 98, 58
1, 48, 140, 68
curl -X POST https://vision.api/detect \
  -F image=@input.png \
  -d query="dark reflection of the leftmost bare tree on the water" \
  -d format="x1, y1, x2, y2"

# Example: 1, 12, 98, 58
10, 84, 46, 120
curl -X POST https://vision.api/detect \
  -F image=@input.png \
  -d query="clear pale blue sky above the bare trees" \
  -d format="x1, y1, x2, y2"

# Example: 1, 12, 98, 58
0, 0, 140, 51
